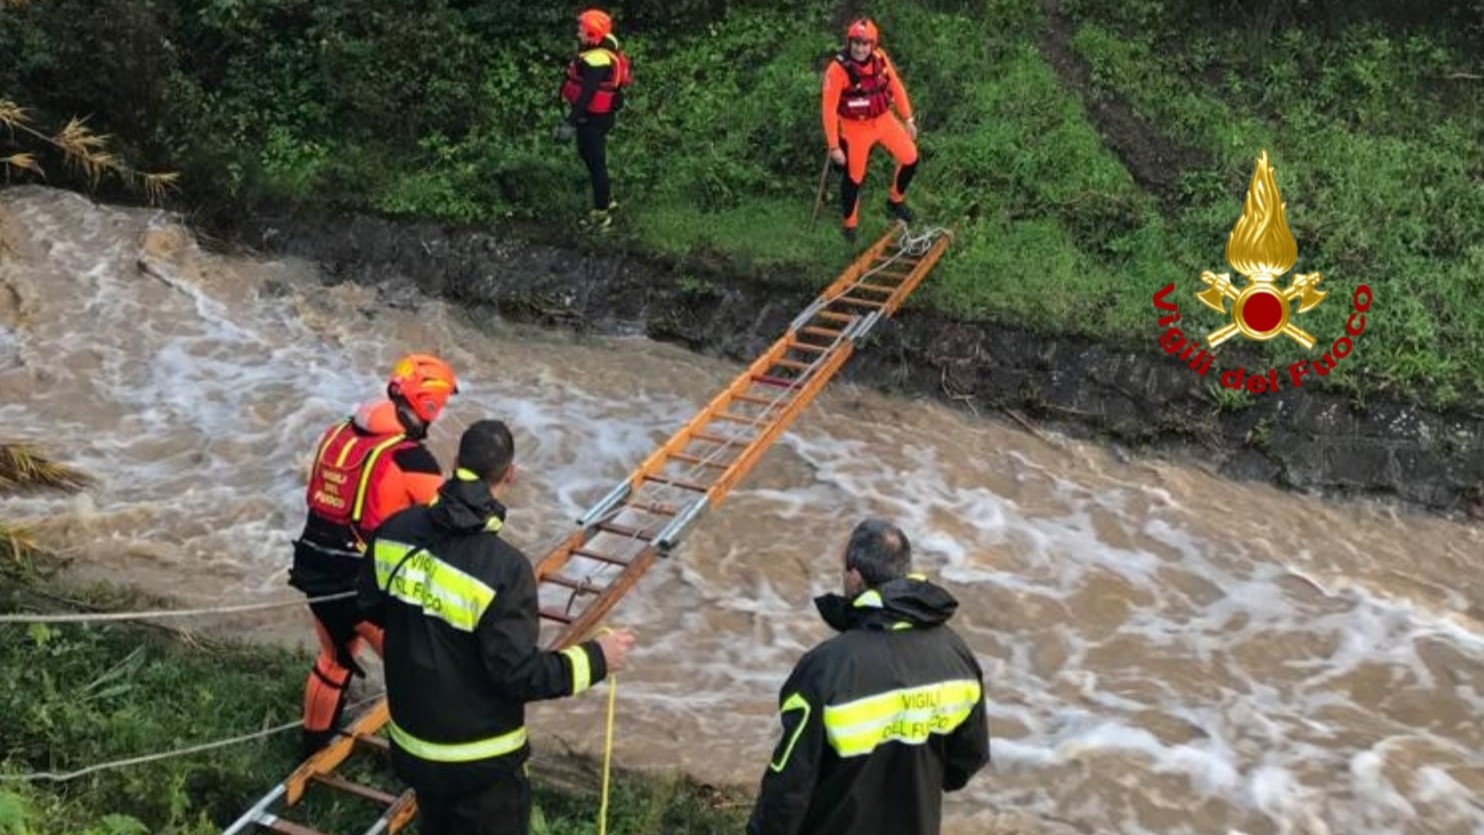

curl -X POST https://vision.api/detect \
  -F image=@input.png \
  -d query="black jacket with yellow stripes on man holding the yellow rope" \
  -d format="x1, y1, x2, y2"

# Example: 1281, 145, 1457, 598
358, 470, 607, 793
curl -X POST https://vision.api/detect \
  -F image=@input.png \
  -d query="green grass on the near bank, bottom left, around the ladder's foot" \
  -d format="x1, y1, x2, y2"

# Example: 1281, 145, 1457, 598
0, 602, 745, 835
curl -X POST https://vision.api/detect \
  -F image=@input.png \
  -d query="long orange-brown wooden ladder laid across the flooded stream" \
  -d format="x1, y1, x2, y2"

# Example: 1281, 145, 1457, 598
223, 225, 951, 835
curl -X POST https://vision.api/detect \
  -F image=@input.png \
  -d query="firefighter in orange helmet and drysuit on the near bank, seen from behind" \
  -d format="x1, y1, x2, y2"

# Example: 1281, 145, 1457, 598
289, 354, 459, 756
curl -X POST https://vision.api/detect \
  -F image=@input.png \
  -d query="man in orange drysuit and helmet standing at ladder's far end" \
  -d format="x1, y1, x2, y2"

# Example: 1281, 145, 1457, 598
821, 18, 917, 243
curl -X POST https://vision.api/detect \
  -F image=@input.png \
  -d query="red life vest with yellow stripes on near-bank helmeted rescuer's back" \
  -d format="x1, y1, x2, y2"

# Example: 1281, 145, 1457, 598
306, 418, 417, 550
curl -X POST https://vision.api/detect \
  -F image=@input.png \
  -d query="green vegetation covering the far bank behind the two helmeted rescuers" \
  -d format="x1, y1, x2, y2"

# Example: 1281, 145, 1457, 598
0, 0, 1484, 405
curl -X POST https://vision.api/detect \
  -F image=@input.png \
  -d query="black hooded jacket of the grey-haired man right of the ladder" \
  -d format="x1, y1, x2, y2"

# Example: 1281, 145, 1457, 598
746, 575, 990, 835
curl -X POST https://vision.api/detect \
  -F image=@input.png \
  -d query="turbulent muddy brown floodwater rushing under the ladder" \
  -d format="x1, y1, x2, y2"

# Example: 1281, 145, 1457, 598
0, 188, 1484, 835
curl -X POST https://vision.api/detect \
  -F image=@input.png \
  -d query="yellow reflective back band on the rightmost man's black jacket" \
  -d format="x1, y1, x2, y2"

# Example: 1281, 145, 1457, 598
825, 679, 981, 756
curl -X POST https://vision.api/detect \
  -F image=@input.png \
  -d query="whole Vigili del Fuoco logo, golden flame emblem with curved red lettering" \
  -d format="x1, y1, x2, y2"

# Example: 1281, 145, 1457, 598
1155, 150, 1371, 395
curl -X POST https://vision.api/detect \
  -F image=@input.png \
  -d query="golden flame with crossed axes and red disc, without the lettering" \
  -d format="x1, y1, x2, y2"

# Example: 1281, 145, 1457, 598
1196, 150, 1328, 349
